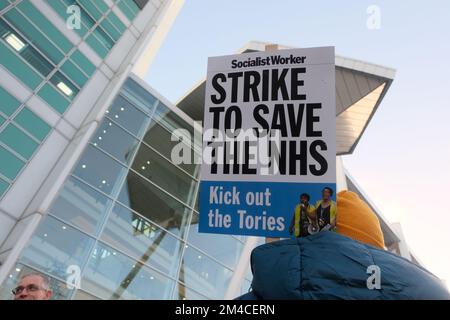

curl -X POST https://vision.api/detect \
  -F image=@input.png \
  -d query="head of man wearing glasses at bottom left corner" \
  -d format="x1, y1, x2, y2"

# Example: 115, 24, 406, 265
13, 273, 53, 300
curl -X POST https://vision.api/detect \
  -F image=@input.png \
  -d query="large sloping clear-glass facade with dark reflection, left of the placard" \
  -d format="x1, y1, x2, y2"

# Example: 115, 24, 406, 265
0, 77, 250, 299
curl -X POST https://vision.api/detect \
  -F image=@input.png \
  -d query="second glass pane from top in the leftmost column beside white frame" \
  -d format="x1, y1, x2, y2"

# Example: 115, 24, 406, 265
106, 95, 149, 137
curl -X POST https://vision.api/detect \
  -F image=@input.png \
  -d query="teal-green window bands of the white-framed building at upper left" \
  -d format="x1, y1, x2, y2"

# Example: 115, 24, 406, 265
0, 0, 156, 197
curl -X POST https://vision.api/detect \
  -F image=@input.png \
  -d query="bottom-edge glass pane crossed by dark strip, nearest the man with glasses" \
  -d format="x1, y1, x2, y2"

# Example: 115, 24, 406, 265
81, 243, 173, 300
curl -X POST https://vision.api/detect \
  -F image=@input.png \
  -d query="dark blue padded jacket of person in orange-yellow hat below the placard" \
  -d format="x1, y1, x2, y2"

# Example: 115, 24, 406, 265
238, 232, 450, 300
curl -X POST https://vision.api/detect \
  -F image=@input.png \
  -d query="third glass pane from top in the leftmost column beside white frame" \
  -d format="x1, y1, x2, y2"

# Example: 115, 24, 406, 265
91, 119, 139, 164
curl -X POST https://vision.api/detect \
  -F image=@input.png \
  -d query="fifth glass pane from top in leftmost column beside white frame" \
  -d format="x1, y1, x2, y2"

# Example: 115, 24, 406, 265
49, 178, 111, 234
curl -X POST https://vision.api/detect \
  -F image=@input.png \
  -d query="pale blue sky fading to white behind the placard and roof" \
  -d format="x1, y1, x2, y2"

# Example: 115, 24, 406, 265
146, 0, 450, 285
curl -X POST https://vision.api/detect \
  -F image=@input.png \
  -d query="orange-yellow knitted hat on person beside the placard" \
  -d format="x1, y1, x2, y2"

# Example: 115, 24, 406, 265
336, 190, 384, 249
